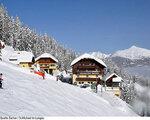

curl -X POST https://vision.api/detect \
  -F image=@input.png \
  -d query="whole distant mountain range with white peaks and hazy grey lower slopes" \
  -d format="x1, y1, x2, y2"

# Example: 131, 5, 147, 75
91, 46, 150, 78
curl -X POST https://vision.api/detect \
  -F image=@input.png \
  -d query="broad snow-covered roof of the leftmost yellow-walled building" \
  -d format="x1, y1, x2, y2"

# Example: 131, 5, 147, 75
9, 51, 34, 64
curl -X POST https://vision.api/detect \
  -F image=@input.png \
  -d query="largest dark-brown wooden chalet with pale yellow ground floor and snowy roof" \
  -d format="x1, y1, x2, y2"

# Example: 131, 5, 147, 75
71, 54, 106, 85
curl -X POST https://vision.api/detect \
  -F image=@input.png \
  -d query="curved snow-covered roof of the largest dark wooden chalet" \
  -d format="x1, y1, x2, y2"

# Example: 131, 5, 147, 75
71, 53, 107, 67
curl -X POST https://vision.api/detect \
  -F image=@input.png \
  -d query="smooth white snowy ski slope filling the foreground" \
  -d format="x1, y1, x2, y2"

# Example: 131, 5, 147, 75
0, 62, 136, 116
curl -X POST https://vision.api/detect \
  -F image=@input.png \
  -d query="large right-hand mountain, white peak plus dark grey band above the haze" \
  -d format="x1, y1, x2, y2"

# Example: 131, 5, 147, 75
110, 46, 150, 68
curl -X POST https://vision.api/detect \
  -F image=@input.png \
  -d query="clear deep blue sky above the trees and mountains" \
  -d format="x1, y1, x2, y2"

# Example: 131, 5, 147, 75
0, 0, 150, 53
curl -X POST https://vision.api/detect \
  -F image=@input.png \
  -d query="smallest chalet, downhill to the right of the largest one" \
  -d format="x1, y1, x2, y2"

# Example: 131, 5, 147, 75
105, 73, 122, 96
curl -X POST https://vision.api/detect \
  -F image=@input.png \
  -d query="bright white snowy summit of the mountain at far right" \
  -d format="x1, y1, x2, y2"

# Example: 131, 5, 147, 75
112, 46, 150, 60
